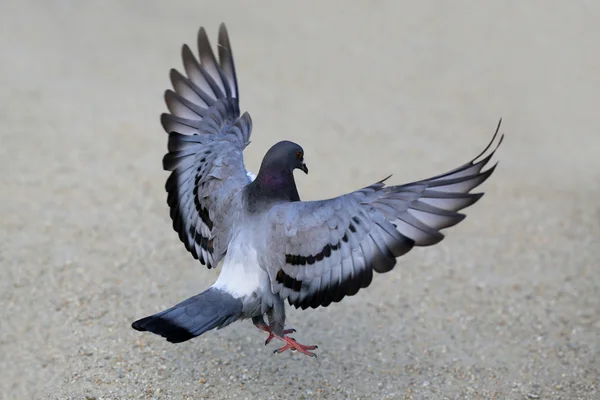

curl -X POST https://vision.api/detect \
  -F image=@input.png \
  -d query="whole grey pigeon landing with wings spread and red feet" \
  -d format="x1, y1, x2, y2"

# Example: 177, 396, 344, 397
132, 24, 503, 357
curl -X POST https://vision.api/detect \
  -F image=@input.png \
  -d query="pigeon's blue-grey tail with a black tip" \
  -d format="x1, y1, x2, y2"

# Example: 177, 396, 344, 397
131, 287, 242, 343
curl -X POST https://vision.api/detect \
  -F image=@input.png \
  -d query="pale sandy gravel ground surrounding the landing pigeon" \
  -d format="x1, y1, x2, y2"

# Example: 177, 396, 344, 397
0, 0, 600, 399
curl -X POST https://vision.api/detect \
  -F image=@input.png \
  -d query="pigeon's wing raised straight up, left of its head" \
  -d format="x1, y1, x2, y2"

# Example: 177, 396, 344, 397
161, 24, 252, 268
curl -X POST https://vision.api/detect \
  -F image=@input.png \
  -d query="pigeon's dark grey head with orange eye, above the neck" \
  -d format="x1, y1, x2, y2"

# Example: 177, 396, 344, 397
259, 140, 308, 175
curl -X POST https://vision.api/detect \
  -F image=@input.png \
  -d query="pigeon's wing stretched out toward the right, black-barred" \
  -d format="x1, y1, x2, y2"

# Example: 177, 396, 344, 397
259, 124, 502, 309
